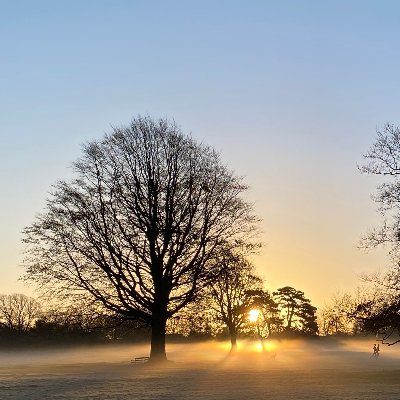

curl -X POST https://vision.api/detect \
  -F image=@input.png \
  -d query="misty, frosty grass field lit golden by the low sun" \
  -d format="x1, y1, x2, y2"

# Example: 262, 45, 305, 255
0, 341, 400, 400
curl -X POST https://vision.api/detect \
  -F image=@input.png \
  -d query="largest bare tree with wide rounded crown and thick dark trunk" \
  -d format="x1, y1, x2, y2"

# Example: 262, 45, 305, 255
24, 117, 257, 360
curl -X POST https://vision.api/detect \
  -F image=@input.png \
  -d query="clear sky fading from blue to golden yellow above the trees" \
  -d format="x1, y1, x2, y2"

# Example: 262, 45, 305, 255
0, 0, 400, 306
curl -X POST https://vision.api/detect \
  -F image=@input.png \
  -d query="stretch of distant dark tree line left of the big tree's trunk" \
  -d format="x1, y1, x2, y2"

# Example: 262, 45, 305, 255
0, 294, 149, 347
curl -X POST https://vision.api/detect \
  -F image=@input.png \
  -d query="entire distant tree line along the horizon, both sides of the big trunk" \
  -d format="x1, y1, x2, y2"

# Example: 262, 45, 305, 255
0, 282, 384, 349
